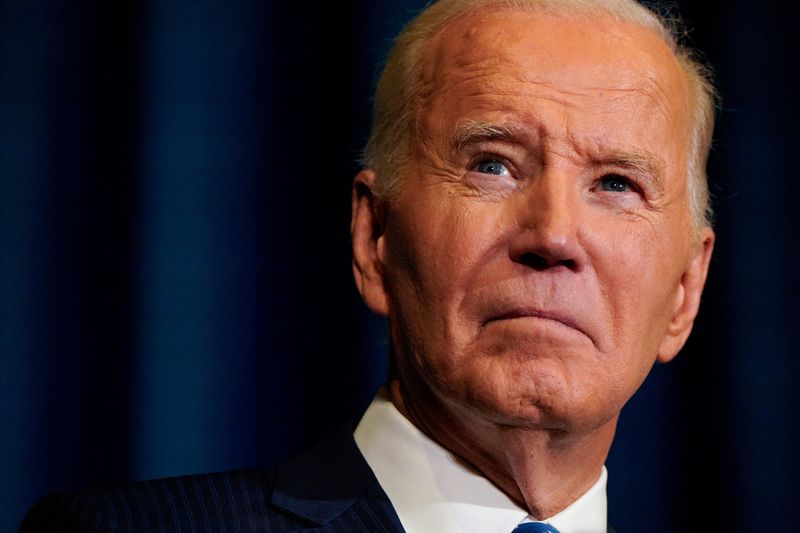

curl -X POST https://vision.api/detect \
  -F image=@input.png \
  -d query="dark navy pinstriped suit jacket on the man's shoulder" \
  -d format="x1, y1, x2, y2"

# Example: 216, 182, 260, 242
20, 429, 403, 533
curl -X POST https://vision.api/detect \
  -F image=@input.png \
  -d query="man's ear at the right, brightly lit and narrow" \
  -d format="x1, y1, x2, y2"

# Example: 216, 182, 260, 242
658, 228, 714, 363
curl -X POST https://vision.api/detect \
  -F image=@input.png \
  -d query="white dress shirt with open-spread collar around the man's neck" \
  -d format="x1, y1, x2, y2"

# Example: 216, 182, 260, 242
354, 392, 608, 533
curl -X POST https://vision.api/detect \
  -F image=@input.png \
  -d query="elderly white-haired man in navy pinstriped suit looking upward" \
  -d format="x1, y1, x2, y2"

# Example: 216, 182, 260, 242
21, 0, 714, 533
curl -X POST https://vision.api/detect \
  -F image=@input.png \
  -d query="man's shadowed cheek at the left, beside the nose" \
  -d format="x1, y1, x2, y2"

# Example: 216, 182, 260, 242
385, 195, 506, 365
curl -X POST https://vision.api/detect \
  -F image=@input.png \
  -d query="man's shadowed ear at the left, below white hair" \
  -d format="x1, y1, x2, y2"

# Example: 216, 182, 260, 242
350, 169, 389, 316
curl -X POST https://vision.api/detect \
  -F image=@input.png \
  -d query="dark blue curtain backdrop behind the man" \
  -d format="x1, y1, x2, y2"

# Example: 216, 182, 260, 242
0, 0, 800, 532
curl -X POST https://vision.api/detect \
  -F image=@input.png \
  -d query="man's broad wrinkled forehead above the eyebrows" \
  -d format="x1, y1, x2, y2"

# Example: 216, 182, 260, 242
417, 7, 691, 162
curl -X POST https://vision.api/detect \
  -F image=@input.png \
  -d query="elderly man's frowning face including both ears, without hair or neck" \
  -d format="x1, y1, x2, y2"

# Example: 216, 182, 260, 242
354, 9, 713, 431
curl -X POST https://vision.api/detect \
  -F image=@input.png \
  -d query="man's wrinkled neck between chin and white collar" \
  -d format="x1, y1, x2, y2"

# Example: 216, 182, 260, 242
389, 379, 617, 519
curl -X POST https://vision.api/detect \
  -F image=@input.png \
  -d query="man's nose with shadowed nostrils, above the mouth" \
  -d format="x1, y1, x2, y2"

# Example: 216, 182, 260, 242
509, 171, 585, 272
